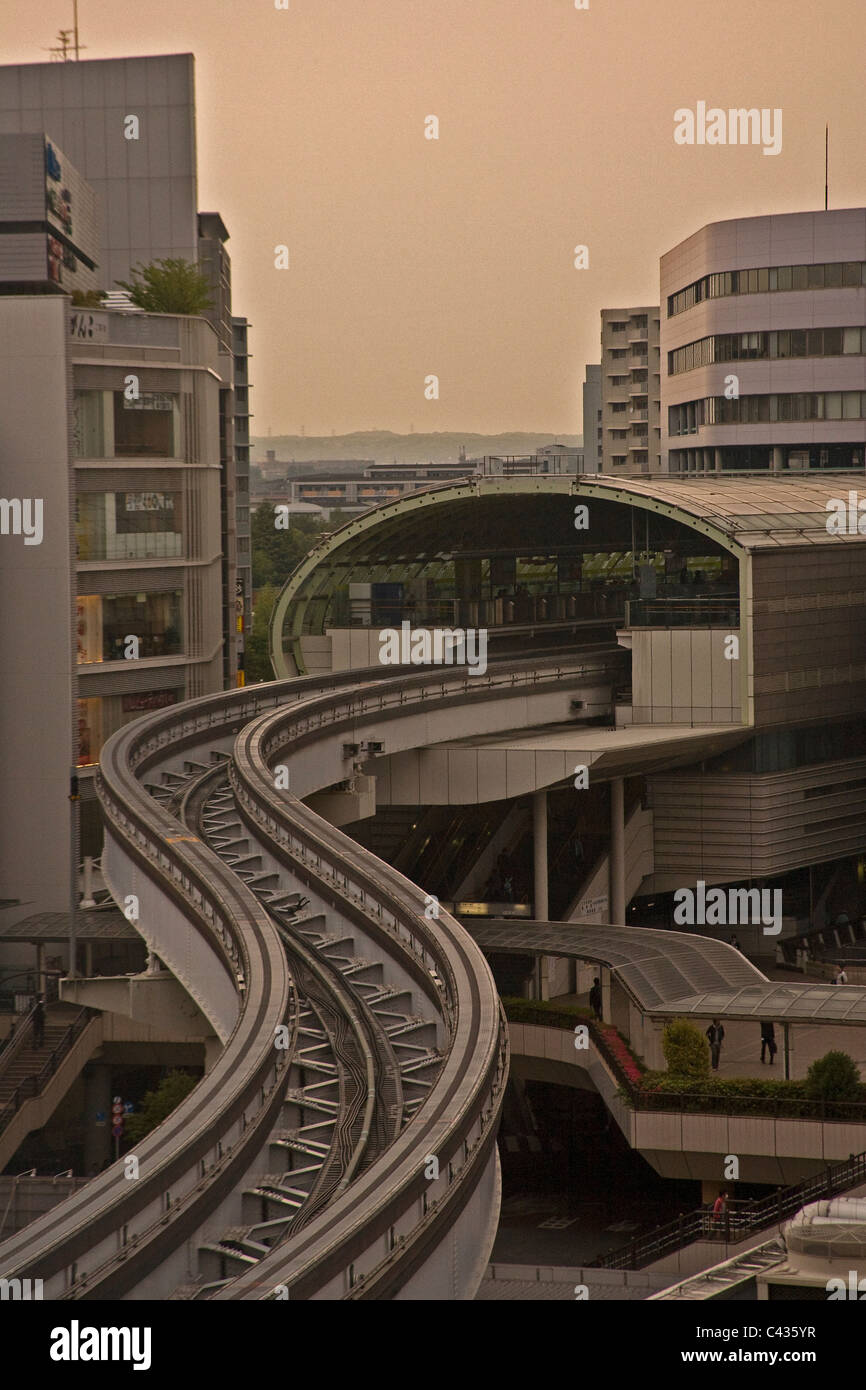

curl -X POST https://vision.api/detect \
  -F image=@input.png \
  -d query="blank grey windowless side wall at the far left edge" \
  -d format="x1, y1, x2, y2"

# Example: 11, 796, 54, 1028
0, 295, 76, 923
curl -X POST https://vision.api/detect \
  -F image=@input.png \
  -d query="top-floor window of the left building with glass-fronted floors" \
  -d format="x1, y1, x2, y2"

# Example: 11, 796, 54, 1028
72, 391, 182, 459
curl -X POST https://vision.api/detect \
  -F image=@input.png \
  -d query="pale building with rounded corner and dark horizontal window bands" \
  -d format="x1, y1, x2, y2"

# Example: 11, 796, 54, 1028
660, 207, 866, 473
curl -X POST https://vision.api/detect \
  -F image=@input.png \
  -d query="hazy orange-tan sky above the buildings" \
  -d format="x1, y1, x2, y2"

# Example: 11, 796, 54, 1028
6, 0, 866, 435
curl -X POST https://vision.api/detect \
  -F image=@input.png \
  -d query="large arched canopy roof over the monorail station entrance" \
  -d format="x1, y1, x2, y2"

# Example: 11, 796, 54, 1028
271, 473, 866, 674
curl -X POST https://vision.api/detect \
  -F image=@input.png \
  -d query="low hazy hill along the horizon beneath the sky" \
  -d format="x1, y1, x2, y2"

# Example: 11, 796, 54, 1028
250, 430, 582, 463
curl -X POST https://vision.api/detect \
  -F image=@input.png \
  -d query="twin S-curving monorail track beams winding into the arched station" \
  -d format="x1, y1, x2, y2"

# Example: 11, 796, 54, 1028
0, 646, 612, 1298
